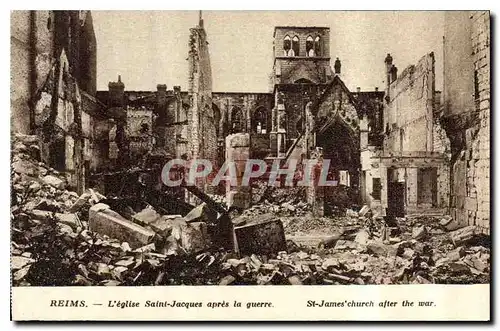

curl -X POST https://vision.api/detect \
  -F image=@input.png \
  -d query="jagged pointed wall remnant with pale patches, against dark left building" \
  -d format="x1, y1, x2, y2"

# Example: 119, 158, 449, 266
34, 51, 98, 193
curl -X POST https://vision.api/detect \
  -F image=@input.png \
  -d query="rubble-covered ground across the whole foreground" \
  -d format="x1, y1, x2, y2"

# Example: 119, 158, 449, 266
11, 135, 490, 286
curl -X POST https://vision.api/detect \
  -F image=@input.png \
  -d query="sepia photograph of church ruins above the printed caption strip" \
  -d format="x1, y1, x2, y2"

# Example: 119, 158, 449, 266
10, 10, 491, 320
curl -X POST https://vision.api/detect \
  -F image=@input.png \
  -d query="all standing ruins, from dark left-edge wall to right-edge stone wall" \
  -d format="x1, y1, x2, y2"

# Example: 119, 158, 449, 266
11, 11, 490, 235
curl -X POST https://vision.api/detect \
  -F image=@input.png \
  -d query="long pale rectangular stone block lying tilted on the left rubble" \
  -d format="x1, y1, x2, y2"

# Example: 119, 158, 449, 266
89, 203, 155, 249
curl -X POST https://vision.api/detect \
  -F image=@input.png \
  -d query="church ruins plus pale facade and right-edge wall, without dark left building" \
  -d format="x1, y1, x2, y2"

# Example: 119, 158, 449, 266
93, 13, 489, 228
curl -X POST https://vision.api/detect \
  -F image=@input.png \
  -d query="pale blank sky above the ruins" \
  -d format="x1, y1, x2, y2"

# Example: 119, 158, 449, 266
92, 11, 444, 92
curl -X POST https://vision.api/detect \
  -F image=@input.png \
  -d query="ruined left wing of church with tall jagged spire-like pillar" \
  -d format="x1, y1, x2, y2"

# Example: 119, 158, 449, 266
97, 18, 220, 183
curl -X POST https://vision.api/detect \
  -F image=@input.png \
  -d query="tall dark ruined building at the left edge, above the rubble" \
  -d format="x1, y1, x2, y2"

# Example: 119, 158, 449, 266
11, 11, 116, 192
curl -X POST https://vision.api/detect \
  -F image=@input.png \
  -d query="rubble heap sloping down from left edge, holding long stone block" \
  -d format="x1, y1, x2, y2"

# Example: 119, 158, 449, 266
11, 134, 210, 286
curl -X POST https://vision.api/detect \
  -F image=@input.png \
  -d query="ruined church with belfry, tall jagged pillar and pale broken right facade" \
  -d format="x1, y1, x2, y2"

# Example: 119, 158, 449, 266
97, 19, 449, 220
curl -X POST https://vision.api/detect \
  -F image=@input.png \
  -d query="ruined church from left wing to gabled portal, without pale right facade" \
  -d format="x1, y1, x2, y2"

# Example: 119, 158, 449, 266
98, 25, 383, 213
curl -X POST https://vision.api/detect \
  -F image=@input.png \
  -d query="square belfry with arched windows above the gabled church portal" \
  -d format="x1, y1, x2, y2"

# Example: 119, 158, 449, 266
270, 26, 383, 216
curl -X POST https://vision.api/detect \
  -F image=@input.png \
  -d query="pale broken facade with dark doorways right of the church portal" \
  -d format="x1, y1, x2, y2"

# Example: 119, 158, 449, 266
362, 53, 449, 216
